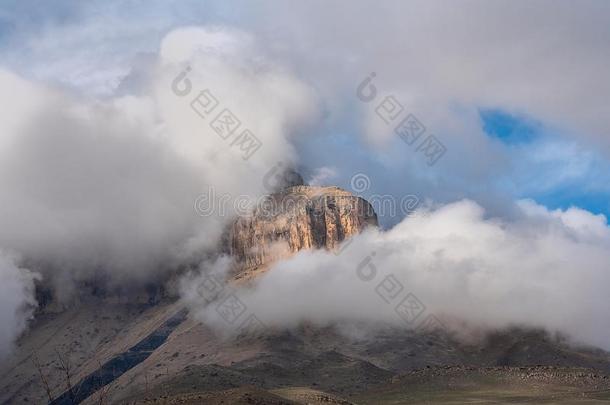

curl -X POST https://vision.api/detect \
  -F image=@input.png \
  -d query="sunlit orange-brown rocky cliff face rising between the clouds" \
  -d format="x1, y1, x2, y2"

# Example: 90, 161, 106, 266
229, 185, 377, 274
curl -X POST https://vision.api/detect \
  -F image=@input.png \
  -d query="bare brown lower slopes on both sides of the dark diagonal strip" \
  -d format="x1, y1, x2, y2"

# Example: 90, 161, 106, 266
0, 300, 610, 404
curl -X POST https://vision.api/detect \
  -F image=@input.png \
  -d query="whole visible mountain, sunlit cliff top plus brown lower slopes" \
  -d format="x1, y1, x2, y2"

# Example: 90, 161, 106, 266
0, 185, 610, 404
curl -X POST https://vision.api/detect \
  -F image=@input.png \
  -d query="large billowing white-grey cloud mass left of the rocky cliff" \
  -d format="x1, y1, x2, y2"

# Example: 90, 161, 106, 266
0, 28, 315, 295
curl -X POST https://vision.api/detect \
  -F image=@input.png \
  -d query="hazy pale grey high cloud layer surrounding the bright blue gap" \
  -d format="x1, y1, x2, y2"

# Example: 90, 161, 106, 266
2, 0, 610, 215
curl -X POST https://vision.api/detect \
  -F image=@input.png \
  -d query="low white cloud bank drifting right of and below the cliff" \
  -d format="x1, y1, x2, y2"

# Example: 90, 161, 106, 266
185, 200, 610, 349
